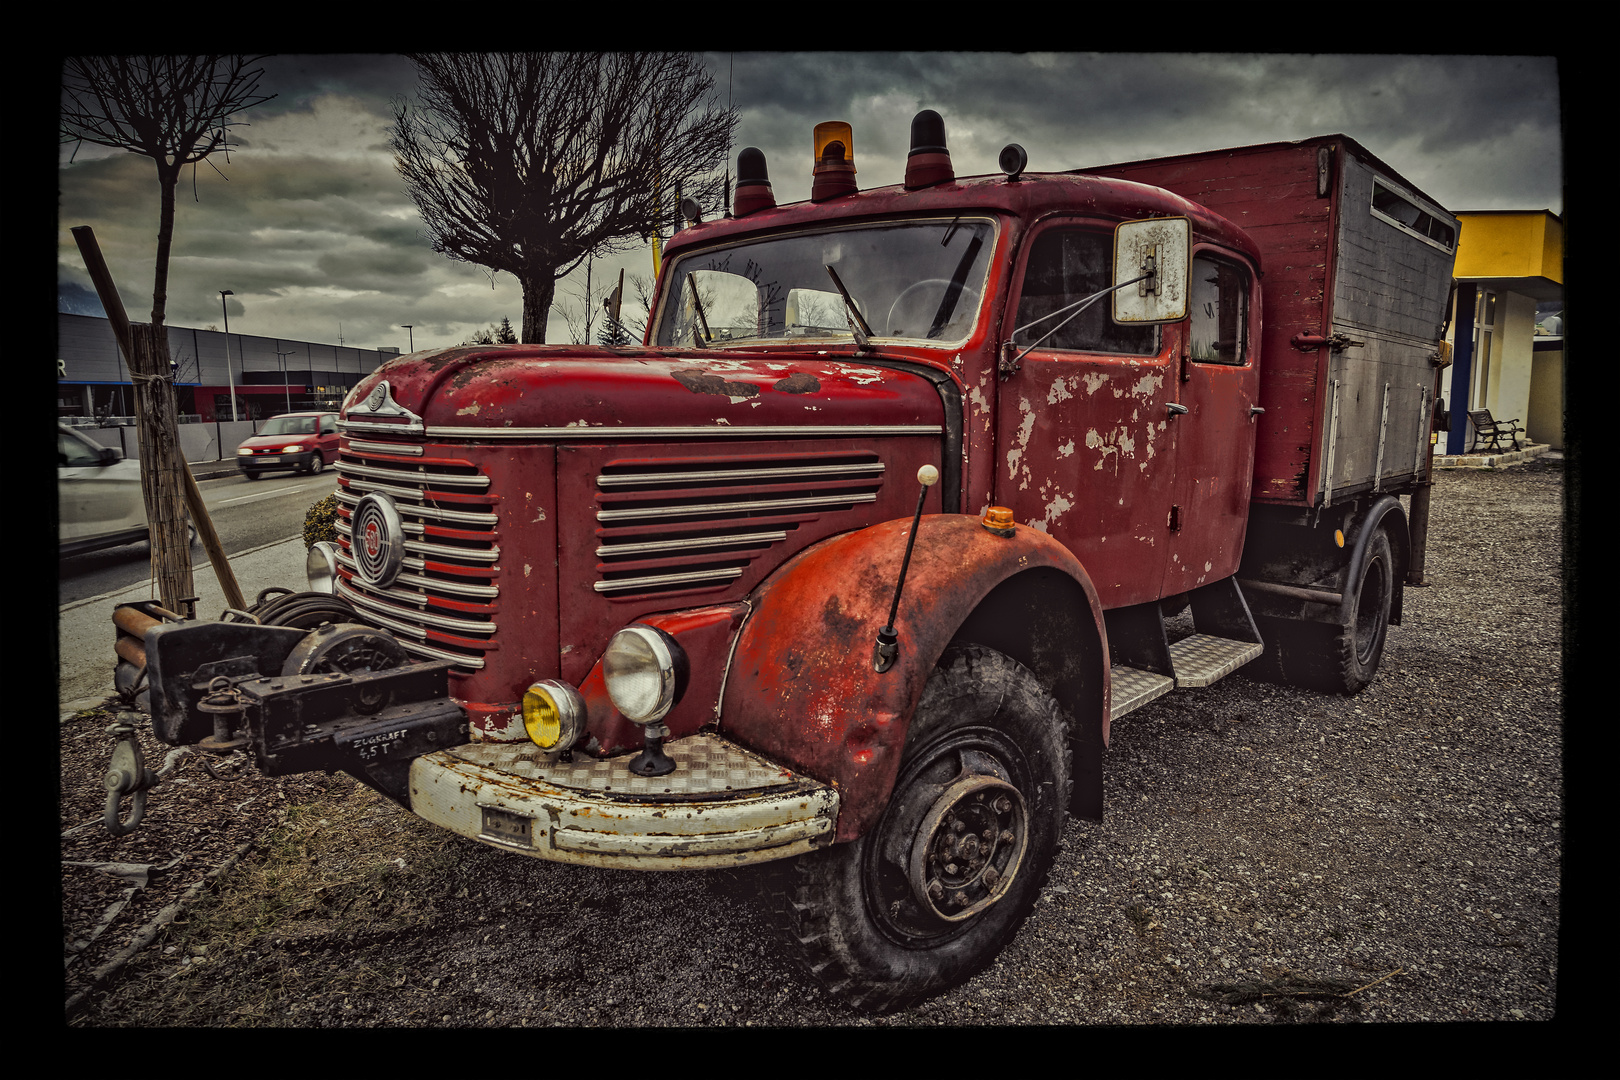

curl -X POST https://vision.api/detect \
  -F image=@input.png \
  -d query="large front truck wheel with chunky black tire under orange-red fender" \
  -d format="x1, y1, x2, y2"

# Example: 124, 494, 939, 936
773, 646, 1071, 1010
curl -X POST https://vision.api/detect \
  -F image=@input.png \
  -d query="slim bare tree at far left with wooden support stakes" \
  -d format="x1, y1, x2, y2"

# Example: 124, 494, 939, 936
58, 55, 271, 609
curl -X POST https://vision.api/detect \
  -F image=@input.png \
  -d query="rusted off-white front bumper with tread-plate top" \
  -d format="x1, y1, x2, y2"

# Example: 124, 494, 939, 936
410, 733, 839, 870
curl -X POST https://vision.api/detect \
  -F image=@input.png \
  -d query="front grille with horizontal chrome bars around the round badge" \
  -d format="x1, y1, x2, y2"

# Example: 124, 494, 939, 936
337, 440, 501, 670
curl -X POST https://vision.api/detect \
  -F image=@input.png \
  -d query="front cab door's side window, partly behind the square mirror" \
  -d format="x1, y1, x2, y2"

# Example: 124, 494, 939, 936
1013, 228, 1158, 356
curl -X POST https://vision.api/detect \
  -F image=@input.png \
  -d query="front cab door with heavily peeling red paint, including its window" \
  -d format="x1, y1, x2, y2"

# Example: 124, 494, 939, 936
996, 219, 1179, 609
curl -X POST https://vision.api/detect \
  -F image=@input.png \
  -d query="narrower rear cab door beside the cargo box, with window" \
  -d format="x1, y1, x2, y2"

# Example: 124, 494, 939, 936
1162, 248, 1260, 596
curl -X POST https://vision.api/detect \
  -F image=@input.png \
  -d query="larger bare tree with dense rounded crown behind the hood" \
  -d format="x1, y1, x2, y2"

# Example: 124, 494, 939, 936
392, 52, 737, 342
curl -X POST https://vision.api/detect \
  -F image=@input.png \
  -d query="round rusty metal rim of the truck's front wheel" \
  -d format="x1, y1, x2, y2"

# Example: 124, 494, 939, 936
862, 729, 1030, 949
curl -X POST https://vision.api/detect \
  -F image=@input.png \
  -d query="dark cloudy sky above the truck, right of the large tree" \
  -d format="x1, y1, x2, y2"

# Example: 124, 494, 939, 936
708, 53, 1562, 209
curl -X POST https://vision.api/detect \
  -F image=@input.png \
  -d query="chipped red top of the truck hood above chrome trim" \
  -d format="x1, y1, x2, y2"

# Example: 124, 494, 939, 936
343, 345, 941, 437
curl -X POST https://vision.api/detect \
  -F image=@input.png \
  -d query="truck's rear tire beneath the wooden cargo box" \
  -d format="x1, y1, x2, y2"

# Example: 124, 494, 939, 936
1256, 528, 1396, 695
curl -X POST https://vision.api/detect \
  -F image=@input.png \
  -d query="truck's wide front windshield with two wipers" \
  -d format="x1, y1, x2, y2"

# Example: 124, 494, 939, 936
656, 217, 995, 347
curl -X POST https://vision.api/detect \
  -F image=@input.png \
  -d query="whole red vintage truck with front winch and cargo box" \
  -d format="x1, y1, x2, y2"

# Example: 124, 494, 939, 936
109, 112, 1456, 1007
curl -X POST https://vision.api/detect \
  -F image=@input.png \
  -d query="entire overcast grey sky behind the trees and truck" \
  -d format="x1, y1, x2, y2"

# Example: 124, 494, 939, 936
58, 52, 1563, 351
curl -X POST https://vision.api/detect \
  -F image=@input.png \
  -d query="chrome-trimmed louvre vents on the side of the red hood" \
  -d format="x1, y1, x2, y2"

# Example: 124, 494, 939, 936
593, 452, 883, 599
